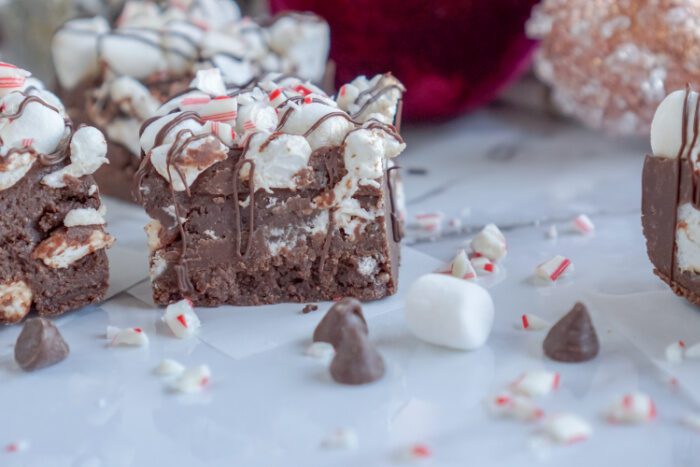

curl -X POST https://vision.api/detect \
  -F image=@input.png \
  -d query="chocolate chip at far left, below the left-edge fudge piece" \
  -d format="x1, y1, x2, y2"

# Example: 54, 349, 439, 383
15, 318, 69, 371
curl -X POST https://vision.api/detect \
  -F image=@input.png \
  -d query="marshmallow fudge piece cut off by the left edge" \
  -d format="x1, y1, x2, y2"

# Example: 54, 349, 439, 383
0, 63, 113, 324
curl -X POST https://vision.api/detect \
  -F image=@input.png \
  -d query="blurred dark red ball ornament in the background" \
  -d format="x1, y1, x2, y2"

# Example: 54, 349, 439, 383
270, 0, 537, 119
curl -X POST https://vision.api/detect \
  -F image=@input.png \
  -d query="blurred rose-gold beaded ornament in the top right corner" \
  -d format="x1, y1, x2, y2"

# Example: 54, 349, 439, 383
527, 0, 700, 134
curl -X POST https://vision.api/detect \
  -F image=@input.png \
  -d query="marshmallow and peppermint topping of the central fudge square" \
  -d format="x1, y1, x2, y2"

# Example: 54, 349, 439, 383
136, 69, 405, 236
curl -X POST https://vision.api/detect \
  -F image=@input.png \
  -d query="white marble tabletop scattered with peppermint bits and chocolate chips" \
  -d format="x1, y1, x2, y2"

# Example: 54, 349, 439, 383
0, 104, 700, 467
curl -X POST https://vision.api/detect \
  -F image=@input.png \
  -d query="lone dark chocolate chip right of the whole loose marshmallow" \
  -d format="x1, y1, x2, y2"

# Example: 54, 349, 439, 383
542, 302, 600, 362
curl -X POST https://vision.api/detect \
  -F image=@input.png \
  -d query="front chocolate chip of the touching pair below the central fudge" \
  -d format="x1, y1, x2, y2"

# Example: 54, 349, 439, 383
330, 324, 384, 384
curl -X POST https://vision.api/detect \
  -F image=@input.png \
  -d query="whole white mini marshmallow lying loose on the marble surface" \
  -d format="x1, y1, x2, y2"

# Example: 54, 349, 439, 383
405, 274, 494, 350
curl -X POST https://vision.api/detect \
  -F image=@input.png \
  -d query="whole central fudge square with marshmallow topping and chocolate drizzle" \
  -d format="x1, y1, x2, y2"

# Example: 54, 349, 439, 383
134, 70, 405, 306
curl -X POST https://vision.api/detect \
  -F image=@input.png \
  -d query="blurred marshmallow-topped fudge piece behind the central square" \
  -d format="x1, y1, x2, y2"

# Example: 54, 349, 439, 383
52, 0, 329, 201
